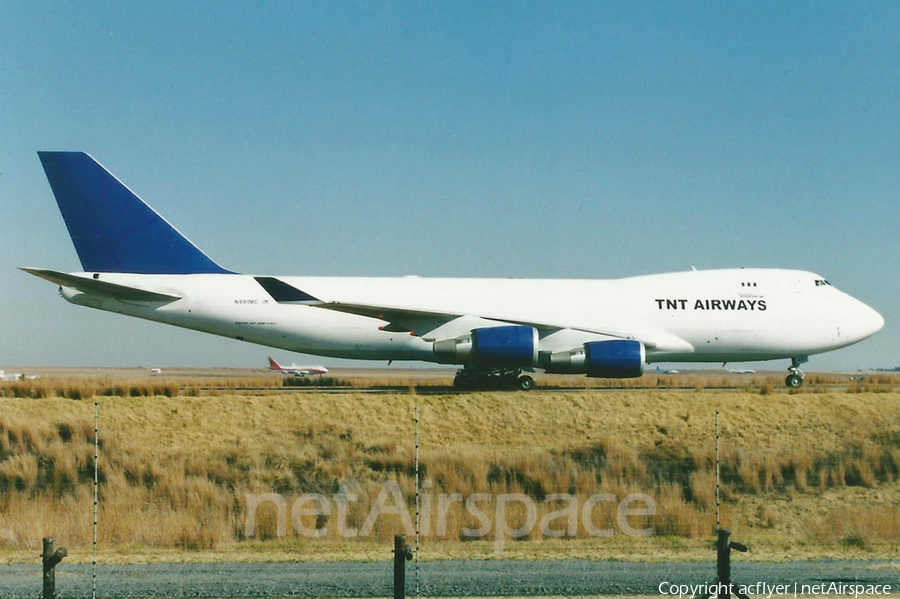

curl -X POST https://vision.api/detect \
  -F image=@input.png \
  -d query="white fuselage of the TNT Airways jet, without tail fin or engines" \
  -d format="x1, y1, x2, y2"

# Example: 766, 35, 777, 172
62, 269, 884, 362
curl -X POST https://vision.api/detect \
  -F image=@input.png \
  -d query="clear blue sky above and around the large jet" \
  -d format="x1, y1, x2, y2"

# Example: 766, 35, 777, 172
0, 0, 900, 370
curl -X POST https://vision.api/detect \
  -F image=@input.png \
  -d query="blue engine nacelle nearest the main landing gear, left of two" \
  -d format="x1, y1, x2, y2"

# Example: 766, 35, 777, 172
434, 325, 538, 367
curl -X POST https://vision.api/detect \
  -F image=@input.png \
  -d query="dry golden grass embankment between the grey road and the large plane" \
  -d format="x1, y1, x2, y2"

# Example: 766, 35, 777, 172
0, 379, 900, 561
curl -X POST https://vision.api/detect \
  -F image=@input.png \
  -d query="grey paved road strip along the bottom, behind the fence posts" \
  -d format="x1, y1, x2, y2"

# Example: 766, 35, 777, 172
0, 560, 900, 599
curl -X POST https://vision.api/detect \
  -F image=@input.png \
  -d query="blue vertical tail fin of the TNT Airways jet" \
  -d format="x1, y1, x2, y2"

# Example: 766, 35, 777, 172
38, 152, 231, 275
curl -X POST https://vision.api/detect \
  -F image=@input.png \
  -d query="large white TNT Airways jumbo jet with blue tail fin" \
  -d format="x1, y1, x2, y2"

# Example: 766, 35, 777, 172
23, 152, 884, 389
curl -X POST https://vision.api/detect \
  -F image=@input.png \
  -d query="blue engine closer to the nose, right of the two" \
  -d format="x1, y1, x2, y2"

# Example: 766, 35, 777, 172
541, 339, 646, 379
